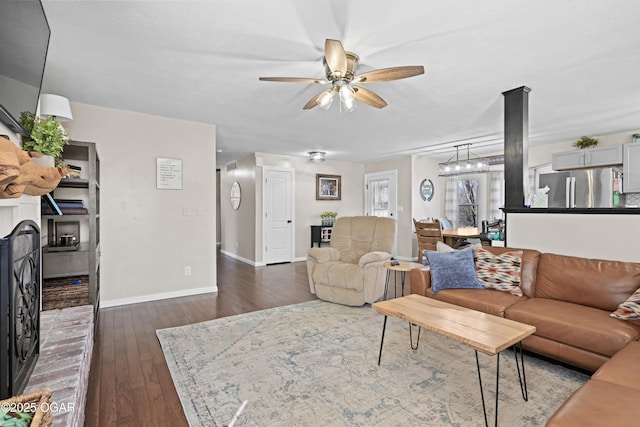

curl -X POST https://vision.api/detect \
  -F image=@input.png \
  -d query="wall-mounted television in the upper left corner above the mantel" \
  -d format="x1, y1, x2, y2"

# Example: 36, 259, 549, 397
0, 0, 51, 136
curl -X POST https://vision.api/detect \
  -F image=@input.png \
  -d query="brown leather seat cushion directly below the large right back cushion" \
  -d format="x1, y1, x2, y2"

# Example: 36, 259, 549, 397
505, 298, 640, 357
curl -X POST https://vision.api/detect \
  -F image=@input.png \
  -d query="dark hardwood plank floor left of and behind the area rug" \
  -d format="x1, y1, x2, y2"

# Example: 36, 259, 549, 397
85, 254, 316, 427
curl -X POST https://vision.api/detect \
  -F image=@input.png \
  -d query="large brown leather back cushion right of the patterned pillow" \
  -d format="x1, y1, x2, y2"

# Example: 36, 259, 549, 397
535, 253, 640, 312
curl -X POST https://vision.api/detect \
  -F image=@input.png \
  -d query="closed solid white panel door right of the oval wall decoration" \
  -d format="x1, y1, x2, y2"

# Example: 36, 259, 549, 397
262, 167, 294, 264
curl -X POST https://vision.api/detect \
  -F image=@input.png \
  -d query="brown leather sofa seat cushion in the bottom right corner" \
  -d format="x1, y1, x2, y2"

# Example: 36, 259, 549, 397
547, 380, 640, 427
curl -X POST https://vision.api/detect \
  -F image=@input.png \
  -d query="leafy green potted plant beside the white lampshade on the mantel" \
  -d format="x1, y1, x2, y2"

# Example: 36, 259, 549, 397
20, 111, 69, 166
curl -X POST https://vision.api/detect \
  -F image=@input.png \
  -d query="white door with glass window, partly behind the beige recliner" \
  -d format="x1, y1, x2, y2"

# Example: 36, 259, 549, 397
364, 170, 398, 255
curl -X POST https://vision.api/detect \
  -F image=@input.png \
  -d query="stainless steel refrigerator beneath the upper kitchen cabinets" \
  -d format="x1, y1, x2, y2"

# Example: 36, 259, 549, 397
538, 168, 622, 208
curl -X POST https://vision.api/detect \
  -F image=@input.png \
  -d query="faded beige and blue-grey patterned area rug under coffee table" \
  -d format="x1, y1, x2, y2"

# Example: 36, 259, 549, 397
157, 300, 588, 427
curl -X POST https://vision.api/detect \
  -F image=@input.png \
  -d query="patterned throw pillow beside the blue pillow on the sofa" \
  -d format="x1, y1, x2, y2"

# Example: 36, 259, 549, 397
473, 248, 522, 297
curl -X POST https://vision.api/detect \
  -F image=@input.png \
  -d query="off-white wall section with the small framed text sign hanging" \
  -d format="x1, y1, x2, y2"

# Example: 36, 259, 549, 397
66, 103, 217, 307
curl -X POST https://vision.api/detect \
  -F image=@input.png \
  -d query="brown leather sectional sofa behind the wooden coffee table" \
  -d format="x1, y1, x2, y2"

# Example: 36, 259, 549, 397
411, 247, 640, 427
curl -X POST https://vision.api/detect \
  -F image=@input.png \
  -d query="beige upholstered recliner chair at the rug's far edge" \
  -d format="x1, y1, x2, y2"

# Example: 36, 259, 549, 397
307, 216, 396, 306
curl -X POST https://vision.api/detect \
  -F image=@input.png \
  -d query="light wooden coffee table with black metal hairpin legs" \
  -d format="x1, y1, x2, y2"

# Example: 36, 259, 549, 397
373, 294, 536, 426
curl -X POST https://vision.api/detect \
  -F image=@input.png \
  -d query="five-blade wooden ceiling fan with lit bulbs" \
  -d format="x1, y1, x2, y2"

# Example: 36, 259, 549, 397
260, 39, 424, 111
